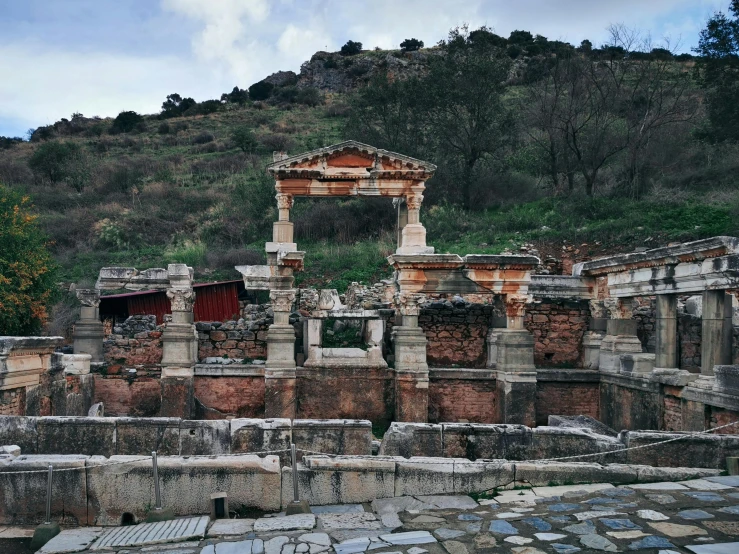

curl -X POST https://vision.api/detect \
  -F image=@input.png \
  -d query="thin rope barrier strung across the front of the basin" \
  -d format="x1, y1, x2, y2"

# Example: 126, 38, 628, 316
0, 420, 739, 475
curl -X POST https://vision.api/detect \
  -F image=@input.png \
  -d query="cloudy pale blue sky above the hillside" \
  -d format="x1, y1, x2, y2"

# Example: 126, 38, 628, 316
0, 0, 729, 136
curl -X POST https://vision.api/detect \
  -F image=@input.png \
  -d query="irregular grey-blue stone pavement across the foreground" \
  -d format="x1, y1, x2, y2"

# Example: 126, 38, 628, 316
14, 477, 739, 554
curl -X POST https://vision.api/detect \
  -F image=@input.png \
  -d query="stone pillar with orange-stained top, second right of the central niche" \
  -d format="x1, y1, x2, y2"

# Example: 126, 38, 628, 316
496, 295, 536, 427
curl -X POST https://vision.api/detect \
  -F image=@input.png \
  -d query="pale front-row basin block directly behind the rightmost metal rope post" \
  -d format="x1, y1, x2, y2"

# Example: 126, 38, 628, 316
282, 456, 395, 507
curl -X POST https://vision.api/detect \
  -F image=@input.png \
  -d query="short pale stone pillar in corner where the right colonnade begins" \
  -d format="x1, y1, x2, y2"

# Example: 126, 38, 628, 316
599, 298, 642, 373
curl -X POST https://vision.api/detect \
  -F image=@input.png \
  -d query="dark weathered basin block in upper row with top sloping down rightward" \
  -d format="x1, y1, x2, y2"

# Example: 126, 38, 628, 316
531, 427, 626, 463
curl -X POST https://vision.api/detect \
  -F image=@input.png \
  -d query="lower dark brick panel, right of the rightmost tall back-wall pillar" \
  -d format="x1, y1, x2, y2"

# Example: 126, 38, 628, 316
536, 381, 600, 425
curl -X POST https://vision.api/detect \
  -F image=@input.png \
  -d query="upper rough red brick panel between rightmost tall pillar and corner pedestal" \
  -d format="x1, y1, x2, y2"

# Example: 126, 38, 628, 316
524, 301, 590, 368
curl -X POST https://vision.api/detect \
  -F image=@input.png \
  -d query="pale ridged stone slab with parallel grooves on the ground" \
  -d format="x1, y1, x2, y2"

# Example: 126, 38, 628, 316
91, 516, 210, 550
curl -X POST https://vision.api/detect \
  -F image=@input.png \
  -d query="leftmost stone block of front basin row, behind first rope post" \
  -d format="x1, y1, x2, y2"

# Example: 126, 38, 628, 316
0, 455, 88, 526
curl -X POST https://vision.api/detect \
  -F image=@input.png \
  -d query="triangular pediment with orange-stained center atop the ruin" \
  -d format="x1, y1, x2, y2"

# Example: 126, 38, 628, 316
267, 140, 436, 175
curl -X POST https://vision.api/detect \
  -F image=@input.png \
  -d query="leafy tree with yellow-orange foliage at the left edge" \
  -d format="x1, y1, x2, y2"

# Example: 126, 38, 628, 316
0, 185, 55, 335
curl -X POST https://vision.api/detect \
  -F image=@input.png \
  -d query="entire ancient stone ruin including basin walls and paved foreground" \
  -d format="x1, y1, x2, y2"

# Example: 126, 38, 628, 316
0, 141, 739, 554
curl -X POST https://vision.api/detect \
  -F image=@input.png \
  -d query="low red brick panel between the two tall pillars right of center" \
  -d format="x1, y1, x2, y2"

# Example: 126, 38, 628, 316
429, 372, 499, 423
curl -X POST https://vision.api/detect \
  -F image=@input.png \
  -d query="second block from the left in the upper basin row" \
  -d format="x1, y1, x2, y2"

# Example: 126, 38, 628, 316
37, 417, 115, 456
